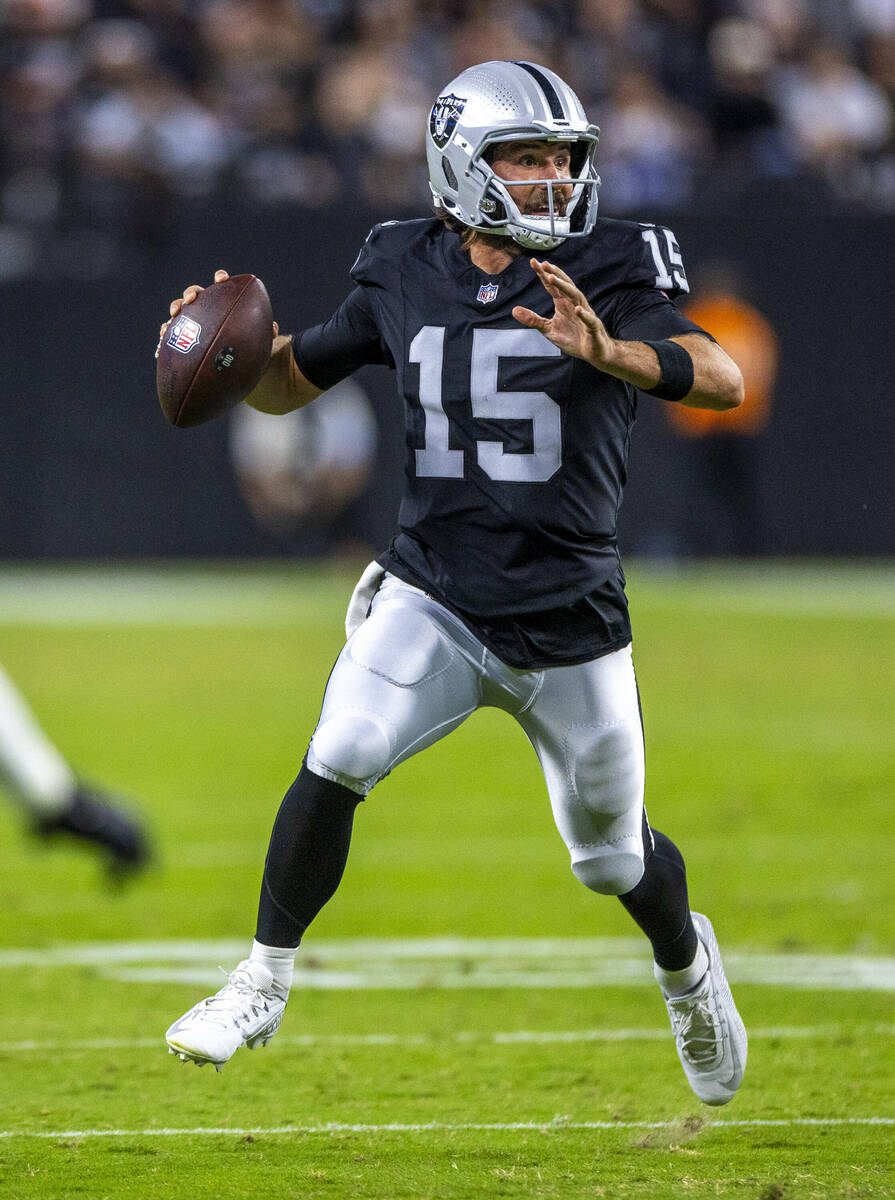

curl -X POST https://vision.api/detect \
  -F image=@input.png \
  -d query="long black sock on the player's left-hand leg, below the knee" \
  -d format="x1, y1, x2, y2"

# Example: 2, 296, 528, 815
254, 766, 364, 947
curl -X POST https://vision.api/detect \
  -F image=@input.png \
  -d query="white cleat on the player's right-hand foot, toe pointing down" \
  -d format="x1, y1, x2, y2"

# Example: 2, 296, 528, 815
662, 912, 747, 1105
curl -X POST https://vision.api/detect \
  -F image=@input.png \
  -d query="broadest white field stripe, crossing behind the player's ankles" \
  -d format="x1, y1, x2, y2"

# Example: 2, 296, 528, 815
0, 937, 895, 991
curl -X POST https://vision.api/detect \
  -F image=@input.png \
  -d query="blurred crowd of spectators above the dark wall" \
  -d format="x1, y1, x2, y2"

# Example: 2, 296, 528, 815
0, 0, 895, 278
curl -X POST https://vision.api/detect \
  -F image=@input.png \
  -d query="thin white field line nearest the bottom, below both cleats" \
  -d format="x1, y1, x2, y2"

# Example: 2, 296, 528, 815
0, 1117, 895, 1139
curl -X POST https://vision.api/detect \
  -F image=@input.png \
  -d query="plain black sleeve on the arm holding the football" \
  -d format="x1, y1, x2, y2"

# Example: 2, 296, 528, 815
293, 287, 395, 389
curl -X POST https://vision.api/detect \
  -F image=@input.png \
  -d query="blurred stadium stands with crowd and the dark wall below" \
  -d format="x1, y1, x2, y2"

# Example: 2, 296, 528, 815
0, 0, 895, 558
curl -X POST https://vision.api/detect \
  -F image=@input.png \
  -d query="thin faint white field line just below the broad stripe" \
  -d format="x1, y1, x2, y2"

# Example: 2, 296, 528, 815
0, 1025, 895, 1054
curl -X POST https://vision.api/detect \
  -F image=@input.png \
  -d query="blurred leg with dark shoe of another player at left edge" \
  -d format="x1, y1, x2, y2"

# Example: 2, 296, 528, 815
0, 667, 149, 880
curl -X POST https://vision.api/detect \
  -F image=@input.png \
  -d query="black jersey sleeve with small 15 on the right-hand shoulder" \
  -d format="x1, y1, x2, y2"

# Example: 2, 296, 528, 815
612, 226, 714, 342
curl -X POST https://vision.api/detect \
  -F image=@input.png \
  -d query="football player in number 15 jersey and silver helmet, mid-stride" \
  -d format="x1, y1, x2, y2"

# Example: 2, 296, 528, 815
167, 61, 746, 1104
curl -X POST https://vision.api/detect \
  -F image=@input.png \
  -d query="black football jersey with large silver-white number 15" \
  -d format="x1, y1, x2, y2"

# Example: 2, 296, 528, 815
294, 218, 703, 668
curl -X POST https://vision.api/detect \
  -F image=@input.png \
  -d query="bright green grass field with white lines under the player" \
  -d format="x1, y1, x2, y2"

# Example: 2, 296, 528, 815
0, 564, 895, 1200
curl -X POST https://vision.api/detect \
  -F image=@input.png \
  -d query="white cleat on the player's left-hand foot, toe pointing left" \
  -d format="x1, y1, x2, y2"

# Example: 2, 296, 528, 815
164, 959, 289, 1070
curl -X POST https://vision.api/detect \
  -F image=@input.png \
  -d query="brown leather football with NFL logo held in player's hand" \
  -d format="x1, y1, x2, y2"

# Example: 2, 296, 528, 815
156, 275, 274, 428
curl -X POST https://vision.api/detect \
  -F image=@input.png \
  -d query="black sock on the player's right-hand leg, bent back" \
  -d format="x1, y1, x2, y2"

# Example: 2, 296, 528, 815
619, 829, 698, 971
